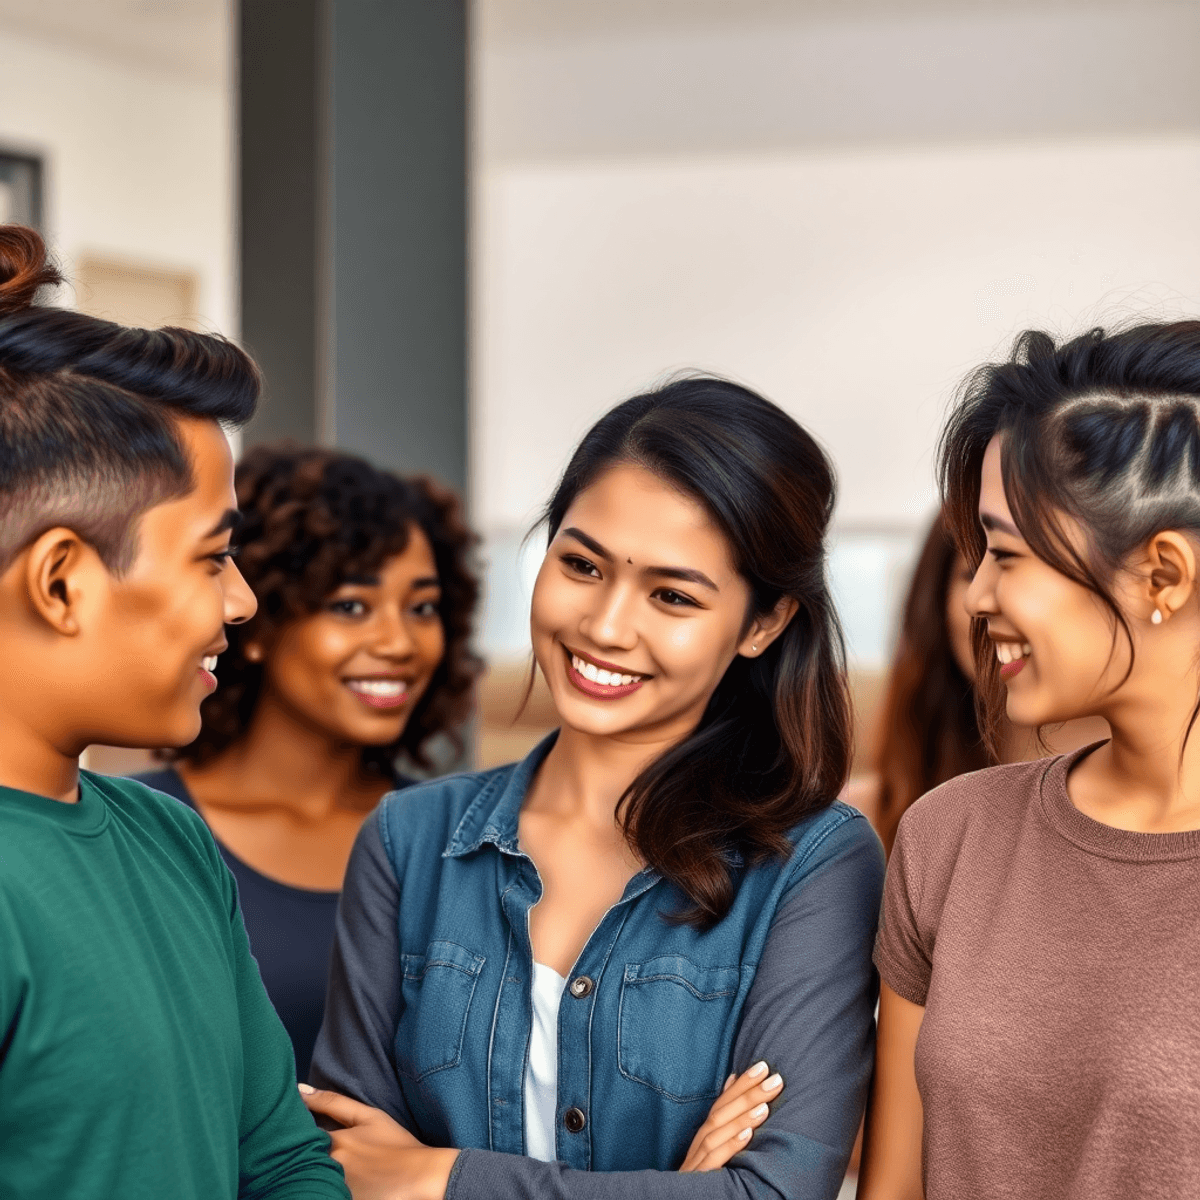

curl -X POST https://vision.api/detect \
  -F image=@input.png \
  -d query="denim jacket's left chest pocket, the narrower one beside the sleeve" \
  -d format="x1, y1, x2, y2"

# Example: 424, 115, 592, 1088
395, 942, 486, 1080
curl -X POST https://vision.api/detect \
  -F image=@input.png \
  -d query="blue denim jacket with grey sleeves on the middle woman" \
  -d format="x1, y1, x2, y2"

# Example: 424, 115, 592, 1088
313, 738, 882, 1198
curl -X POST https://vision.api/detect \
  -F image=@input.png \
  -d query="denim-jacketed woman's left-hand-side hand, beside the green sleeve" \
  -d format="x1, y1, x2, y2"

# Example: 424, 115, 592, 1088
300, 1084, 458, 1200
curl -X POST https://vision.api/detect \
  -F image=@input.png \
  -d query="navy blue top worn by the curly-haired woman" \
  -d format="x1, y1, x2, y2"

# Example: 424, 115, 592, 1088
134, 769, 407, 1080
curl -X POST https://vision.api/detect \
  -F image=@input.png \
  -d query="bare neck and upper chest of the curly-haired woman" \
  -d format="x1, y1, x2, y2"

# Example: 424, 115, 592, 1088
182, 689, 378, 815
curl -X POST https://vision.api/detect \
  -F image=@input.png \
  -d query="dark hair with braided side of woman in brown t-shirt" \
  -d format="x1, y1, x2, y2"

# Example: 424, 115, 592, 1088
938, 320, 1200, 754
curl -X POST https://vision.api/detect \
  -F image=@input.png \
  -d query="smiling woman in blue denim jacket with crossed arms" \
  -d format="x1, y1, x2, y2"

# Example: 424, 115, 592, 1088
306, 378, 883, 1200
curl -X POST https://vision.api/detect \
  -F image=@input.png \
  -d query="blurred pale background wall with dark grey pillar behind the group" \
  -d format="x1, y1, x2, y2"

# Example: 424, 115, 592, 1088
0, 0, 1200, 761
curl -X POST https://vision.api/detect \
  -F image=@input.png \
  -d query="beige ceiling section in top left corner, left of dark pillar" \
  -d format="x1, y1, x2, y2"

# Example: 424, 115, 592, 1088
0, 0, 226, 83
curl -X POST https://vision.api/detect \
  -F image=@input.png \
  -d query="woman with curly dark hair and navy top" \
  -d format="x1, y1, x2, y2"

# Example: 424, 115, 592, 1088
140, 444, 481, 1079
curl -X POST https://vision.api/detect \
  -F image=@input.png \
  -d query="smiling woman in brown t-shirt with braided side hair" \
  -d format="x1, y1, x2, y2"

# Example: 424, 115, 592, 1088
859, 322, 1200, 1200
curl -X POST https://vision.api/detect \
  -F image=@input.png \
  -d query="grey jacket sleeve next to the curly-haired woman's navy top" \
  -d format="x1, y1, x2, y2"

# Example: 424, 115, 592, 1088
308, 810, 413, 1129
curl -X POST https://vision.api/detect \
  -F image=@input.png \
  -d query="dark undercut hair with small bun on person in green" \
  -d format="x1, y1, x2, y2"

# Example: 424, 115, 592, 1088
0, 224, 262, 576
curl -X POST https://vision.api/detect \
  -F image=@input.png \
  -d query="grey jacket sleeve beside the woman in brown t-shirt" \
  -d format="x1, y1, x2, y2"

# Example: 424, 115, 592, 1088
446, 816, 883, 1200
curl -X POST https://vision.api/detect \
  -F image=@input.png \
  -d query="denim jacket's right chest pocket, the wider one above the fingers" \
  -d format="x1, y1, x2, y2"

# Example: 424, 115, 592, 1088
617, 955, 744, 1104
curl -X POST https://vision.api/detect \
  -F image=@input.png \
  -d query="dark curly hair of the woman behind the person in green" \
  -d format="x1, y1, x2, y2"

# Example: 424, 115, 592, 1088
163, 442, 484, 778
